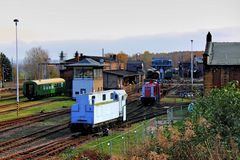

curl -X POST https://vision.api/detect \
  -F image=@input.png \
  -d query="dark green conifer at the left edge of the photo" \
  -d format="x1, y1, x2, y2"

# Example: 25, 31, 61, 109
0, 53, 12, 81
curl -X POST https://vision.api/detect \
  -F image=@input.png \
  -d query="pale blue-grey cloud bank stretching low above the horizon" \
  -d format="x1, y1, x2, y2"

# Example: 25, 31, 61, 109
0, 27, 240, 60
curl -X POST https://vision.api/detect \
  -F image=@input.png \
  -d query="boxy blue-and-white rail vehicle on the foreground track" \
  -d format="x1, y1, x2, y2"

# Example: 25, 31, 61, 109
70, 90, 127, 133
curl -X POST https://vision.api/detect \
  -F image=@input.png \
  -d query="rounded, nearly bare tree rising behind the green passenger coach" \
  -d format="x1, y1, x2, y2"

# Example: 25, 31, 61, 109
23, 47, 50, 79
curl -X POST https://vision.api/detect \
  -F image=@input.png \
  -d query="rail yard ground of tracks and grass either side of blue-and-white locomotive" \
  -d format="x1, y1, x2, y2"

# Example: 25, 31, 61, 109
0, 84, 201, 160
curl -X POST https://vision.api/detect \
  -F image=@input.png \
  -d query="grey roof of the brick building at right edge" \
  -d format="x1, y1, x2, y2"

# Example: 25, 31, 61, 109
207, 42, 240, 65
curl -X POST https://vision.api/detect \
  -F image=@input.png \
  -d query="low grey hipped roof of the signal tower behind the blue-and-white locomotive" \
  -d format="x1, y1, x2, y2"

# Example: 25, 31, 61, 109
66, 58, 103, 67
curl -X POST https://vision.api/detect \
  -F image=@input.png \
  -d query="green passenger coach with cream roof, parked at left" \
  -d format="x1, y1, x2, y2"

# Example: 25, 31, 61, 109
23, 78, 65, 100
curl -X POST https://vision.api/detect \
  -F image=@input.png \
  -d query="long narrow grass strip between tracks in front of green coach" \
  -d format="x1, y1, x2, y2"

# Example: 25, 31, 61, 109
0, 99, 75, 121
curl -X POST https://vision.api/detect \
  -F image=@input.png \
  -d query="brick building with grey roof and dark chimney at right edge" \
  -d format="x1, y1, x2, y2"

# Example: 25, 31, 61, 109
203, 32, 240, 93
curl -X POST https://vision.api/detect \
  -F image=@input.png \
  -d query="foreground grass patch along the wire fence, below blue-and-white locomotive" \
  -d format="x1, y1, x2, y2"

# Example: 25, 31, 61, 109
60, 121, 148, 160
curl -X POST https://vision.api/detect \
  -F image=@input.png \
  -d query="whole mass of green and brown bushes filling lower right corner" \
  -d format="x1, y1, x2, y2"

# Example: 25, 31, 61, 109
122, 82, 240, 160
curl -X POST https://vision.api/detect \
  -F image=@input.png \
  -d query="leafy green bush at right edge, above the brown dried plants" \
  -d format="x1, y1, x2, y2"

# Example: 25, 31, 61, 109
192, 82, 240, 145
